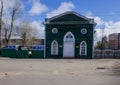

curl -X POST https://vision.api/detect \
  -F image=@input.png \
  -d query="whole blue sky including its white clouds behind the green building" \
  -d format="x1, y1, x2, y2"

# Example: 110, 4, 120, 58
4, 0, 120, 40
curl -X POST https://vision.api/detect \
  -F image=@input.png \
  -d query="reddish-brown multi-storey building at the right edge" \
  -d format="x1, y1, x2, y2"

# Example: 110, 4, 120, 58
109, 33, 120, 50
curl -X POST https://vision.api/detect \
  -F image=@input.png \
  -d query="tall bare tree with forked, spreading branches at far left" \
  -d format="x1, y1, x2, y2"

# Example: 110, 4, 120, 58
0, 0, 23, 47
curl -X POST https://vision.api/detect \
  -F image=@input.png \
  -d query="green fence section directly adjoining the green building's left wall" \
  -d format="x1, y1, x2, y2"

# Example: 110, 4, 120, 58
31, 50, 44, 59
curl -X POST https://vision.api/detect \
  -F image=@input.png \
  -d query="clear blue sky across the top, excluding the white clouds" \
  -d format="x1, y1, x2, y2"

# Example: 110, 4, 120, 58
23, 0, 120, 21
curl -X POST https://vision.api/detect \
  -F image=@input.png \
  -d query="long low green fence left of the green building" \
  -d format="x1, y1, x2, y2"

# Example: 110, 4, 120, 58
1, 49, 44, 59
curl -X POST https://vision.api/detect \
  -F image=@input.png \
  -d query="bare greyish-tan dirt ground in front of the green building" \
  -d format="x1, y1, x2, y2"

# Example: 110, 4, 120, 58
0, 58, 120, 85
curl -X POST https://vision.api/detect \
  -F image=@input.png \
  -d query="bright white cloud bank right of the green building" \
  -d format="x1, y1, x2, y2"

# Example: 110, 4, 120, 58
95, 17, 120, 40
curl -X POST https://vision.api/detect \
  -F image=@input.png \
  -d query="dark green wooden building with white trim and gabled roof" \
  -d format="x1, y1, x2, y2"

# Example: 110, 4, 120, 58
44, 11, 96, 59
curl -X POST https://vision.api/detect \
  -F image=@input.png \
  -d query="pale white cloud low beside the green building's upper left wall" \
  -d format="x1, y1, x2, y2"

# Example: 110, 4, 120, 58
31, 21, 45, 38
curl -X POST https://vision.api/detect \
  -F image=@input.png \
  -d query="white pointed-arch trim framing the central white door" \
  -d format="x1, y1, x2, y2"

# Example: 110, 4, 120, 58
63, 32, 75, 57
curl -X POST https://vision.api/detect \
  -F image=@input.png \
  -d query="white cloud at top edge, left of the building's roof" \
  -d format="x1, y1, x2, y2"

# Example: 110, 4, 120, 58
29, 0, 48, 16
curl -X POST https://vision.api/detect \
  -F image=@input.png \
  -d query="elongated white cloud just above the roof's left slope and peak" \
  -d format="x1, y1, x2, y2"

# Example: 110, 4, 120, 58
46, 2, 75, 18
